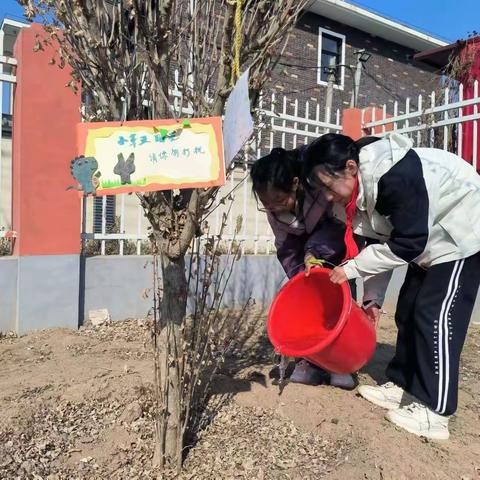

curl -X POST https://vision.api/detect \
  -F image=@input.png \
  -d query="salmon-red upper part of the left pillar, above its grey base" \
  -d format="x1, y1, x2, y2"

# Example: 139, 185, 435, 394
12, 24, 80, 255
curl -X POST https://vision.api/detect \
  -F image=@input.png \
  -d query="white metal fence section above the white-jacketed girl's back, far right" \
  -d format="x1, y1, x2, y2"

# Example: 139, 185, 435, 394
362, 80, 480, 165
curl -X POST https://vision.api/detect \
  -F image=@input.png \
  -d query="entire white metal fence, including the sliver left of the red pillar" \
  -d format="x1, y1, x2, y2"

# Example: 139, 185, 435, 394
5, 49, 480, 255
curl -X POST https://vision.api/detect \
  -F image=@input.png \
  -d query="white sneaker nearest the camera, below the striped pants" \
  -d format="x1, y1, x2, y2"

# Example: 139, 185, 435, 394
385, 402, 450, 440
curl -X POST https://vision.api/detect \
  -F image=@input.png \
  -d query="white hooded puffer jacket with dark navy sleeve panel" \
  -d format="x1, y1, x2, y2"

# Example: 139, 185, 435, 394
344, 133, 480, 300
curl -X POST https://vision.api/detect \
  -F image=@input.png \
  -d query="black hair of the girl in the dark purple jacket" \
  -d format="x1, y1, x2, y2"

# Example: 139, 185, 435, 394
250, 148, 302, 197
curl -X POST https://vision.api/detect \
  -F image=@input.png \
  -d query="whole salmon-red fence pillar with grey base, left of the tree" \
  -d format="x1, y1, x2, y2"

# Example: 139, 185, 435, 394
12, 24, 80, 333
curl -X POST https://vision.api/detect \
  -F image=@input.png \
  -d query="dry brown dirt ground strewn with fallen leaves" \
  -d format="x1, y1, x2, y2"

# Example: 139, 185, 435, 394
0, 316, 480, 480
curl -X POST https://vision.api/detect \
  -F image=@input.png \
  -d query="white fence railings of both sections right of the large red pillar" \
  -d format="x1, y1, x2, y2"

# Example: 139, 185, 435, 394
78, 81, 480, 254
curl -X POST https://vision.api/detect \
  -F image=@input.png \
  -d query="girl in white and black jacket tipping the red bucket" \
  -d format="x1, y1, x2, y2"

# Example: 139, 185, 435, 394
304, 133, 480, 439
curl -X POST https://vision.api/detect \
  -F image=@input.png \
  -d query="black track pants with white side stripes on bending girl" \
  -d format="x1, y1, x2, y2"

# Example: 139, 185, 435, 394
387, 252, 480, 415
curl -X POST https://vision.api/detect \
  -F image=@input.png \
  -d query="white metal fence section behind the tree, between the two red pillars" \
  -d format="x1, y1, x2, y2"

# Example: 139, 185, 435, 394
84, 91, 342, 255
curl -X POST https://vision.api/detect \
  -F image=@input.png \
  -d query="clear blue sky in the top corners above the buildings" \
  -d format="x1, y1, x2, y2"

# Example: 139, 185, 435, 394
0, 0, 480, 41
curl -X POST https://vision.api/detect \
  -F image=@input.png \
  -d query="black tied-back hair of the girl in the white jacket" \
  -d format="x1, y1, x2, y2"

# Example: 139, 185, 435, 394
302, 133, 380, 183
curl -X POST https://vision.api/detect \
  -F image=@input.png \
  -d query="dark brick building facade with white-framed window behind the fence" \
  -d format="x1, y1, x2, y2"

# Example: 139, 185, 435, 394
269, 0, 447, 127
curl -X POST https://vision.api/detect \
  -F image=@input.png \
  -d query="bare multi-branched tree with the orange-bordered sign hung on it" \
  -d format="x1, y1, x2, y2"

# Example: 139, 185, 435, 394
18, 0, 308, 472
